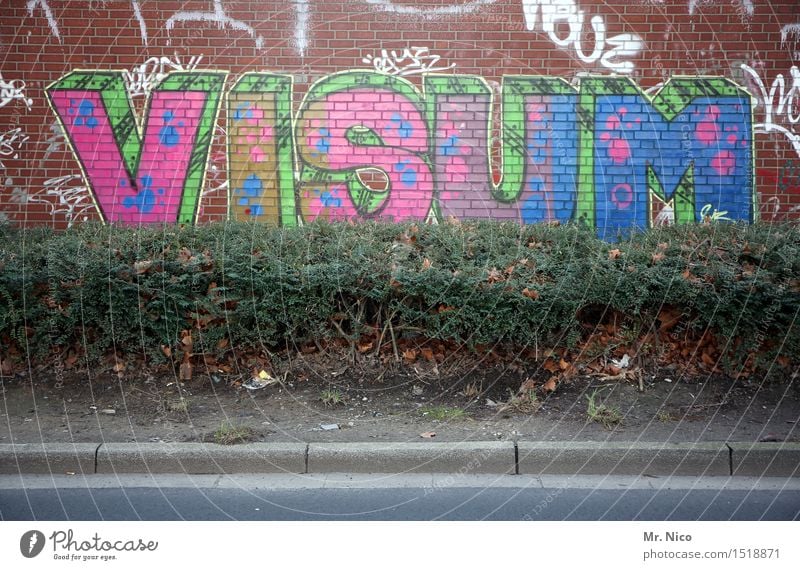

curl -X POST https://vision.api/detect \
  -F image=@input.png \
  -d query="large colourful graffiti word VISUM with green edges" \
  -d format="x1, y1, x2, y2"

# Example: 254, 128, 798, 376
48, 70, 756, 237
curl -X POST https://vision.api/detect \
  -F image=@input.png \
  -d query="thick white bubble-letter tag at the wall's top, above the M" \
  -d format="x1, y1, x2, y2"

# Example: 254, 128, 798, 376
522, 0, 643, 73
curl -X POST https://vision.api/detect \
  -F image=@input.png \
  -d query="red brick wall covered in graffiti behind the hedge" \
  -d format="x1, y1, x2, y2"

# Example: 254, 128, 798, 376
0, 0, 800, 237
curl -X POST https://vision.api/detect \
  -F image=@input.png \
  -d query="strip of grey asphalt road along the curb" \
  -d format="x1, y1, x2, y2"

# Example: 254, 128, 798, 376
0, 475, 800, 521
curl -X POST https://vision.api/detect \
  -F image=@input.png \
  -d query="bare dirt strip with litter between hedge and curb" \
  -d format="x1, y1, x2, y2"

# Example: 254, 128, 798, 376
0, 352, 800, 443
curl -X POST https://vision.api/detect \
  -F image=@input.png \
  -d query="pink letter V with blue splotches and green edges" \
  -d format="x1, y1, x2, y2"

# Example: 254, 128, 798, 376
46, 71, 226, 223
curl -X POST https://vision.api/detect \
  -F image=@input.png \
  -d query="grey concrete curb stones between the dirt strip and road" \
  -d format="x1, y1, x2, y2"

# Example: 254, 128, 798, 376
0, 441, 800, 477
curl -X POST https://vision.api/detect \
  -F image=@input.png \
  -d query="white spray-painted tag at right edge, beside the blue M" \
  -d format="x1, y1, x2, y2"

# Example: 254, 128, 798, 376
741, 64, 800, 156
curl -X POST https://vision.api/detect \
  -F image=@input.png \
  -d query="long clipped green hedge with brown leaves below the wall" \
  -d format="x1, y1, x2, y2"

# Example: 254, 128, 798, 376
0, 222, 800, 370
